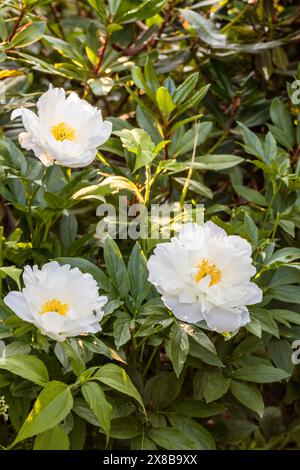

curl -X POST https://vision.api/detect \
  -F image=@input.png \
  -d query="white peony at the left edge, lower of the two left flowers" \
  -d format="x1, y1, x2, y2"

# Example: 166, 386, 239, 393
4, 261, 107, 341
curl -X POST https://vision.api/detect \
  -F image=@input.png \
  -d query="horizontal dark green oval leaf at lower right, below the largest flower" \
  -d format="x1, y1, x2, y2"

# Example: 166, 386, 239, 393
232, 364, 289, 383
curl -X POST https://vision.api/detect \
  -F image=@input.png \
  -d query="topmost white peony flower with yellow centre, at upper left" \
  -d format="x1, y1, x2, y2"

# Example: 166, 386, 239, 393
11, 85, 112, 168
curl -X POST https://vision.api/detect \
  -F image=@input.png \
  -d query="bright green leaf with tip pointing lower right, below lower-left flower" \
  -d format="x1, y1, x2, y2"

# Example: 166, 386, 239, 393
92, 364, 144, 408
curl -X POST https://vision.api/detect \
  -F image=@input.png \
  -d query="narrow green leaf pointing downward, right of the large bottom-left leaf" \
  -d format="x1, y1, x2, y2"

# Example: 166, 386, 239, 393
81, 382, 112, 442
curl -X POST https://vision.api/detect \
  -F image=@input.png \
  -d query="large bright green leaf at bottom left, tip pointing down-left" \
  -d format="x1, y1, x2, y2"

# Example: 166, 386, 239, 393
12, 381, 73, 446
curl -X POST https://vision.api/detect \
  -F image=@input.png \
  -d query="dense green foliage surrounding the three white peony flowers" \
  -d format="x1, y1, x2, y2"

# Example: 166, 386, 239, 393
0, 0, 300, 449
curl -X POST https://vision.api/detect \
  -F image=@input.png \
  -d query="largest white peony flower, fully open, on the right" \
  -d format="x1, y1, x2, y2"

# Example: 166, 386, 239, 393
148, 222, 262, 333
